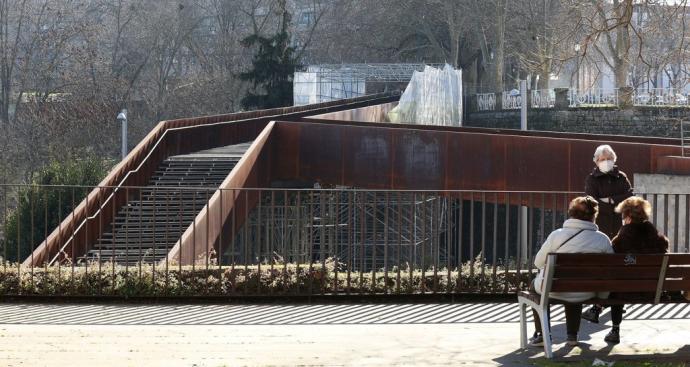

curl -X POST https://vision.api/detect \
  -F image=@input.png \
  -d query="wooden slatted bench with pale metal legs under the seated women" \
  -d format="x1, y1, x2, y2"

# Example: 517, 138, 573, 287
518, 253, 690, 358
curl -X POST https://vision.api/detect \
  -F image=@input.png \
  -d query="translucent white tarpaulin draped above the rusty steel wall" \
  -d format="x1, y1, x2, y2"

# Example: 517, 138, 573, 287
388, 64, 462, 126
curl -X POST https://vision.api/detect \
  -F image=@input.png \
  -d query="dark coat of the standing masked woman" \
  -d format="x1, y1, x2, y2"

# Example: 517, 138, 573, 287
585, 166, 633, 238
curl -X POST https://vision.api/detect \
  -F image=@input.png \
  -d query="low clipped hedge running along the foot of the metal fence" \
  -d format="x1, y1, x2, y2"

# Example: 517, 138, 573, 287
0, 260, 529, 297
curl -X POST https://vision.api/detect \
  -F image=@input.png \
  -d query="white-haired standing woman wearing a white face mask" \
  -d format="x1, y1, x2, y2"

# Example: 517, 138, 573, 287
585, 144, 632, 238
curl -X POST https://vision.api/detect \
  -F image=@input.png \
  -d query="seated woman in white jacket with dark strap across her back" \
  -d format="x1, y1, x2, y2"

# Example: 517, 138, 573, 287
530, 196, 613, 346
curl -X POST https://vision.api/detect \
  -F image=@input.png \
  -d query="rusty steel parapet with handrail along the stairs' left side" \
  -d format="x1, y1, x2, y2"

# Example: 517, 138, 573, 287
24, 95, 398, 265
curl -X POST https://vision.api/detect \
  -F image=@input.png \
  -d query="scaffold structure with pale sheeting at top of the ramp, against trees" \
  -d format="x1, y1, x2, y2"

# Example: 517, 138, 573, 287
293, 63, 438, 106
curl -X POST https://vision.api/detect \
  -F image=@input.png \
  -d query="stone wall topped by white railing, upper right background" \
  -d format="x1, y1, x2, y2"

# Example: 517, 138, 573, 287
463, 107, 690, 138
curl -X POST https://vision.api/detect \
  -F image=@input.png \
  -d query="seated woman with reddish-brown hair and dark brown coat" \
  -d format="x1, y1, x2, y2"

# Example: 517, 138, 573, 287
582, 196, 668, 343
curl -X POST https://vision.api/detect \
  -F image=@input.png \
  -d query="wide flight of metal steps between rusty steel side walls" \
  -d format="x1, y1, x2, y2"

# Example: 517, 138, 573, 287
85, 143, 249, 265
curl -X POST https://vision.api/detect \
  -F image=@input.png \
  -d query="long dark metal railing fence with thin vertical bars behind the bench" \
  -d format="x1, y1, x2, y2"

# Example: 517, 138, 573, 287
0, 185, 690, 296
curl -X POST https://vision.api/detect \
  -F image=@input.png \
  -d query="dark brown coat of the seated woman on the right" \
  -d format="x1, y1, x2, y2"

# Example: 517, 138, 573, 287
611, 221, 668, 254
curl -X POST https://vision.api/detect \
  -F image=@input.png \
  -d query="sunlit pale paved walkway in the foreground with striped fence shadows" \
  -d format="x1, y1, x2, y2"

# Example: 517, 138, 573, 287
0, 304, 690, 367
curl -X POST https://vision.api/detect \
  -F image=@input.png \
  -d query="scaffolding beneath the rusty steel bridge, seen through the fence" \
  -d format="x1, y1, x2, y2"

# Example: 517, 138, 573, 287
224, 191, 452, 271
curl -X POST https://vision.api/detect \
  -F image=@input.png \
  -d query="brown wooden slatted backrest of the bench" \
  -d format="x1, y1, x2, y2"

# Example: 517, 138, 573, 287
543, 253, 690, 303
